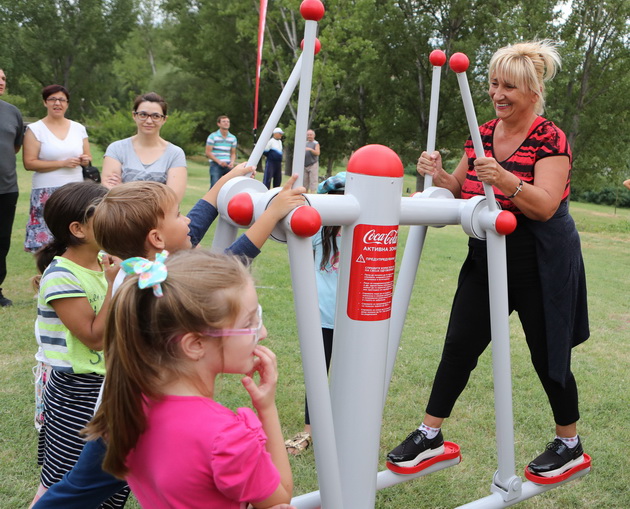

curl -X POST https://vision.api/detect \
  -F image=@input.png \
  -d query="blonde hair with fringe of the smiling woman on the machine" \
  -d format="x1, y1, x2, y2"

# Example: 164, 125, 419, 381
488, 39, 561, 115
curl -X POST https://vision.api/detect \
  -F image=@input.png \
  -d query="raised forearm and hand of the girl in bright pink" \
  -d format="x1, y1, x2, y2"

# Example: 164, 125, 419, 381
241, 345, 293, 509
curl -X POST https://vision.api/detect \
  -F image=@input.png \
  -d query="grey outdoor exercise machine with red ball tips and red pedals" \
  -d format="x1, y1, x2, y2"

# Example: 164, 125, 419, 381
213, 0, 590, 509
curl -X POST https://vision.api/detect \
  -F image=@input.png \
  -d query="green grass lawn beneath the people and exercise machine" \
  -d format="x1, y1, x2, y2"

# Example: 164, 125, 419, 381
0, 153, 630, 509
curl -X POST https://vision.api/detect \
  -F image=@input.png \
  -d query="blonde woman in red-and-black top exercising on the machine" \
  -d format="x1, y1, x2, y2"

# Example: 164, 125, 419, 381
388, 41, 589, 477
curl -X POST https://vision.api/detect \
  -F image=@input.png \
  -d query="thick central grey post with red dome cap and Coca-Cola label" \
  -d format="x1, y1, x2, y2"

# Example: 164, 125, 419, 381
330, 145, 403, 509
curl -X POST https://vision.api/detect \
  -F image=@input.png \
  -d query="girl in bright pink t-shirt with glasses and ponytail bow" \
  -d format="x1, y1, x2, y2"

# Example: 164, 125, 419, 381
88, 250, 293, 509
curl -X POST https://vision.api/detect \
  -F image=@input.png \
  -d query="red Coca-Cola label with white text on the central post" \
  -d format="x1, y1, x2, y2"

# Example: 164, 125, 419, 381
348, 224, 398, 321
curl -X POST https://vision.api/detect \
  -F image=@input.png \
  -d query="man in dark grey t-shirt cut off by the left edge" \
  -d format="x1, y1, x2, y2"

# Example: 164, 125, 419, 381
0, 68, 24, 307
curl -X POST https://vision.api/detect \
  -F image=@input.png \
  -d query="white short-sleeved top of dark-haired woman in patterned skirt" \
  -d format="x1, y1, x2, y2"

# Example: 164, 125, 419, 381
27, 120, 88, 189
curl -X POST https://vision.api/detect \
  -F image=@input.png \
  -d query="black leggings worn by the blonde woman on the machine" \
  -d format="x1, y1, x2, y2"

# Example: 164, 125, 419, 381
426, 234, 580, 426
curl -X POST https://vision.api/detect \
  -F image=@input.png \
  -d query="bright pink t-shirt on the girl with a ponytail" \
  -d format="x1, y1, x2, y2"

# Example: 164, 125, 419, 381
127, 396, 280, 509
